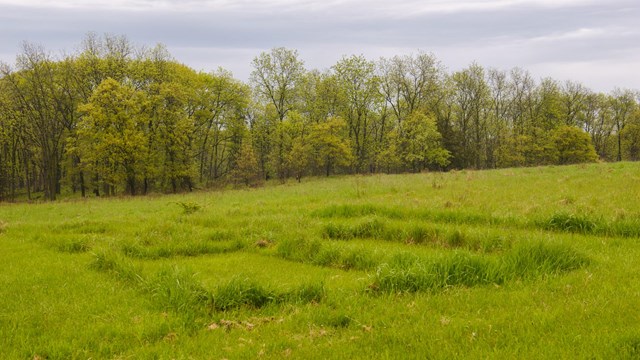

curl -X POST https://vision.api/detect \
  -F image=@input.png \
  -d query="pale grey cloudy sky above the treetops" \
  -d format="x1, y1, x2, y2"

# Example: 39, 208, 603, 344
0, 0, 640, 92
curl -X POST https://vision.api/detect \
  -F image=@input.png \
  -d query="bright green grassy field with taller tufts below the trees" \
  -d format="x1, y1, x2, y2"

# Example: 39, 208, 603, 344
0, 163, 640, 359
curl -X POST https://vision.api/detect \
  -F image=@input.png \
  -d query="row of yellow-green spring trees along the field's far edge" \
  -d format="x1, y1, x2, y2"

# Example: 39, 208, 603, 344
0, 33, 640, 200
